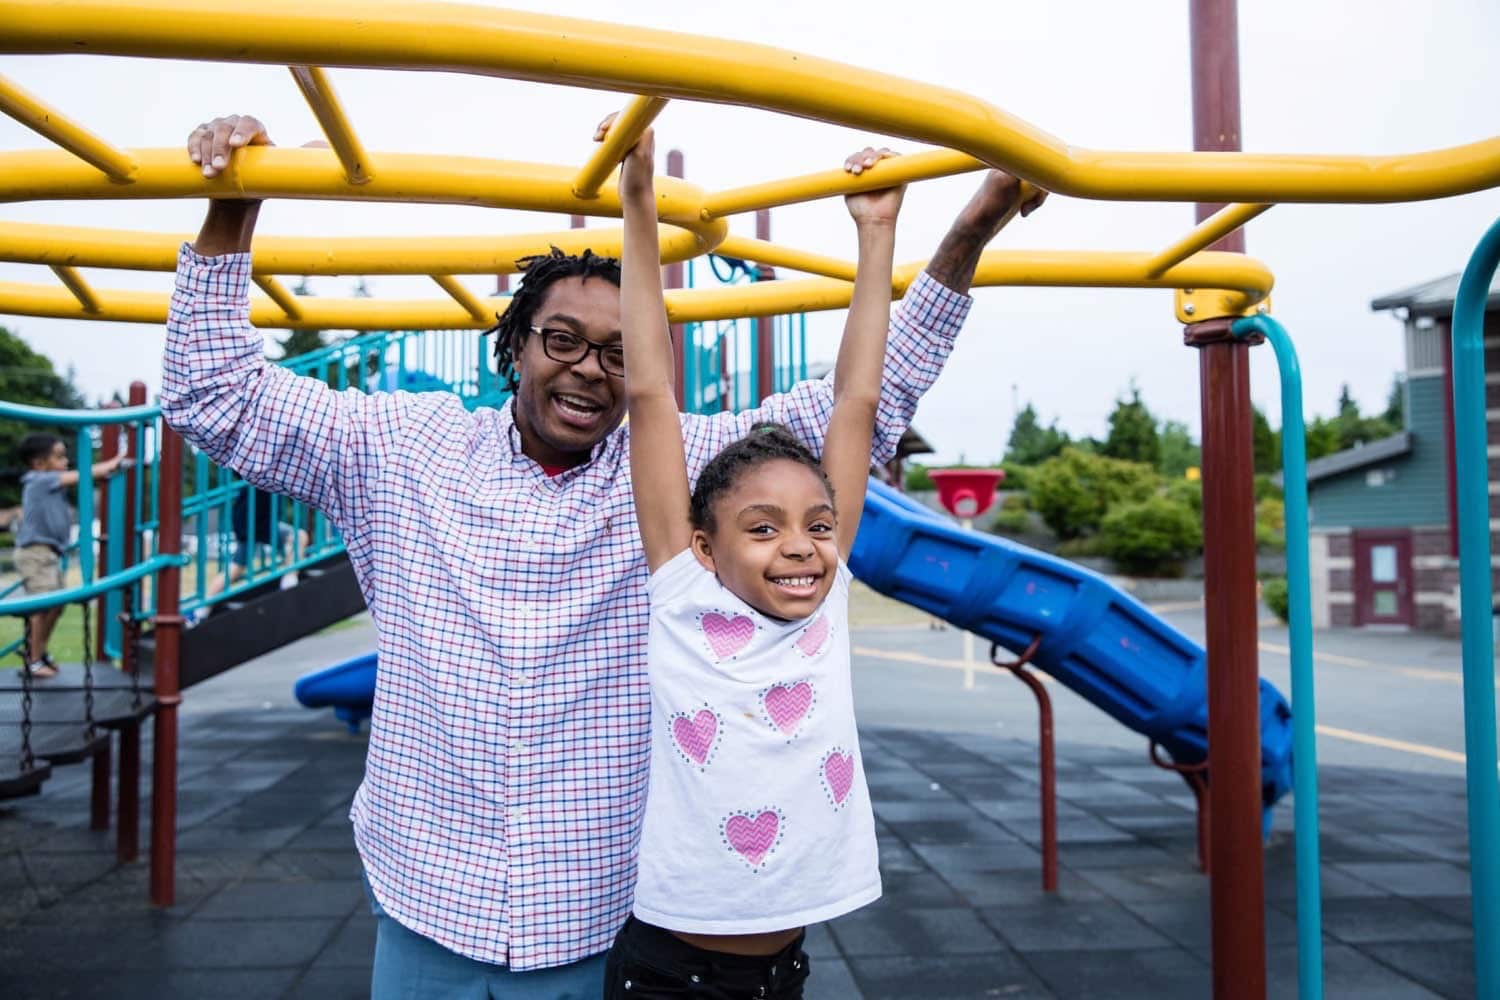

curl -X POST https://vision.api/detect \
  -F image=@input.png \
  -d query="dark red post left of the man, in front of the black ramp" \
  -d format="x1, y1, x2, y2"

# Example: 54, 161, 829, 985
152, 424, 183, 906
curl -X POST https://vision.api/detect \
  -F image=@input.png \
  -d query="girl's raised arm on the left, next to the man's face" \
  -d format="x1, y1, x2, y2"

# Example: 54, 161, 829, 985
606, 118, 692, 571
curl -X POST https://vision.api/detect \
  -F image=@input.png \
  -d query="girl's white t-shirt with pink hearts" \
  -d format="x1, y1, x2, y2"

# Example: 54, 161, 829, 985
635, 552, 881, 934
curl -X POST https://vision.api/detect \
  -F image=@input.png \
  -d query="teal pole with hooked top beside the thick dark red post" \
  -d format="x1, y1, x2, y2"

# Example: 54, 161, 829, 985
1233, 315, 1323, 1000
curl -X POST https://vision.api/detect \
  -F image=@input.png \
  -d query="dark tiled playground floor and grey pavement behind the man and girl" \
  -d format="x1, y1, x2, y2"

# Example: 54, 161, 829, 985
0, 612, 1475, 1000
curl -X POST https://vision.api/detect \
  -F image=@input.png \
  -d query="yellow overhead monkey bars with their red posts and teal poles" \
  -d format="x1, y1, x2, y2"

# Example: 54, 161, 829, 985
0, 0, 1500, 997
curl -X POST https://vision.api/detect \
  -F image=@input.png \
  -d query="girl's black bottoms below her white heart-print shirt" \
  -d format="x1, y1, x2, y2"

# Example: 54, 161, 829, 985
605, 916, 807, 1000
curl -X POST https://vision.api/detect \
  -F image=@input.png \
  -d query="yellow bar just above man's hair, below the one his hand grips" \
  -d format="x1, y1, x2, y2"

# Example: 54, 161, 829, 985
0, 222, 714, 274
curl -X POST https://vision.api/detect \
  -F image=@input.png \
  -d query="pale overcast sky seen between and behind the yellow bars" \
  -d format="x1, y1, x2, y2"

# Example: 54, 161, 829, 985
0, 0, 1500, 460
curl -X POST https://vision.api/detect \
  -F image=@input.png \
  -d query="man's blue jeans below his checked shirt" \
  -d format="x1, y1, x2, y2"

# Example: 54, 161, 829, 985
366, 886, 605, 1000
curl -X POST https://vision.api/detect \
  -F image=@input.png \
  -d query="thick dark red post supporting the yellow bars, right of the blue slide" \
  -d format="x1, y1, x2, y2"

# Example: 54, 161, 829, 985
1187, 0, 1266, 1000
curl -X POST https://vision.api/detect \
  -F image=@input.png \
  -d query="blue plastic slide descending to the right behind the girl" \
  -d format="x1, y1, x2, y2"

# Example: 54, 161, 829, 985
849, 480, 1292, 808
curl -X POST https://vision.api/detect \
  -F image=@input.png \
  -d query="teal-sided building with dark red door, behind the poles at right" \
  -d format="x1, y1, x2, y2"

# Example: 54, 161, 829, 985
1308, 274, 1500, 633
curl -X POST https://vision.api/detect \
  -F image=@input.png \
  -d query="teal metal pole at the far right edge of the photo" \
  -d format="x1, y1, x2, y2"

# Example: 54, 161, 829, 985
1454, 212, 1500, 997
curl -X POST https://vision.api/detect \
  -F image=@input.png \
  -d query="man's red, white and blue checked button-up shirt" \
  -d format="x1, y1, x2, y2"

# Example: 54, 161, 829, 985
162, 246, 971, 970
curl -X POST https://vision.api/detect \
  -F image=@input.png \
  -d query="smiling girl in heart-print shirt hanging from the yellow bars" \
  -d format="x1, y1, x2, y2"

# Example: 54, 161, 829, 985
603, 123, 903, 999
